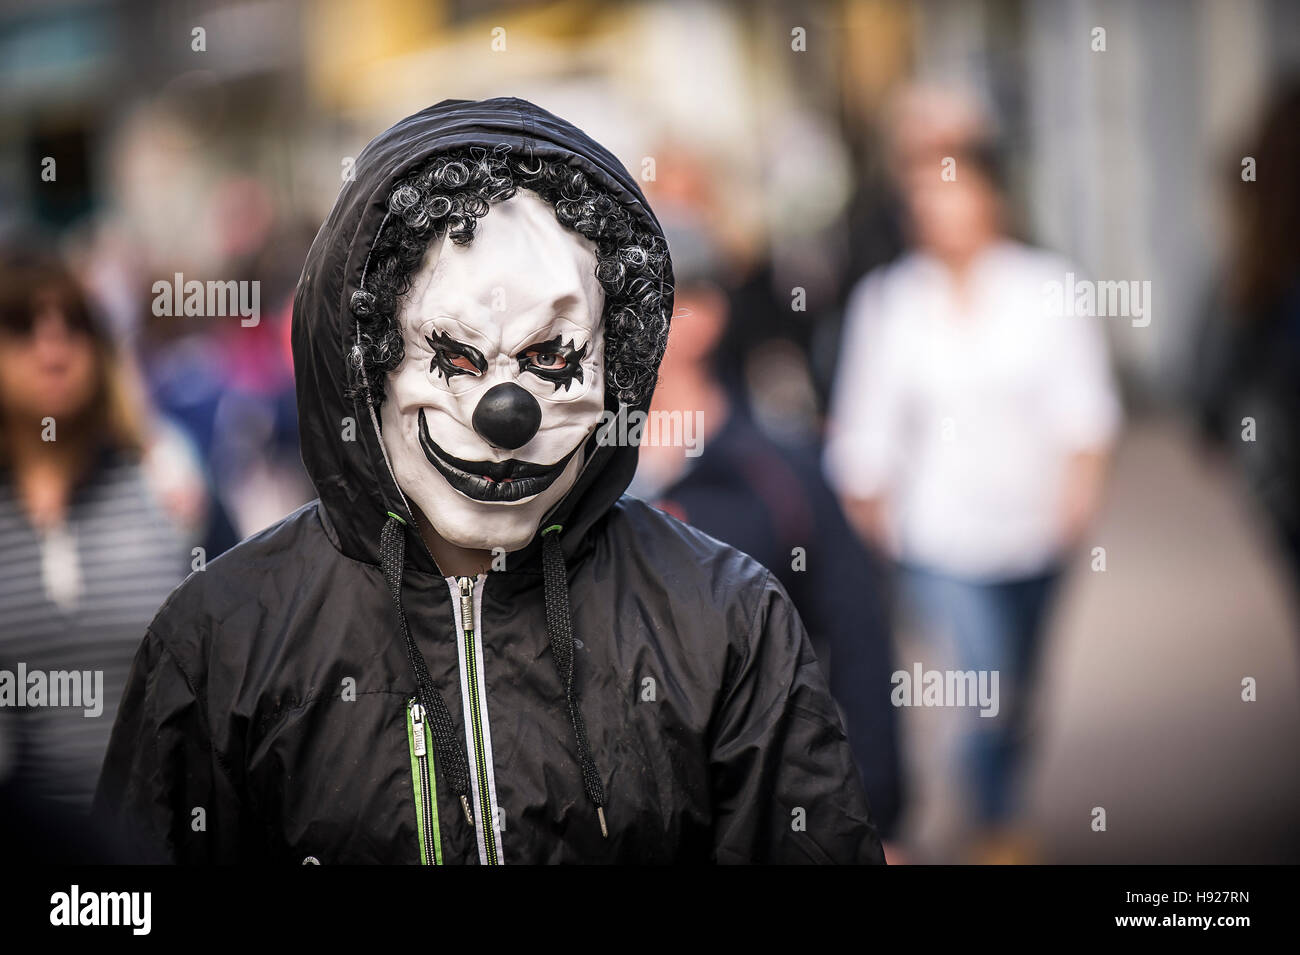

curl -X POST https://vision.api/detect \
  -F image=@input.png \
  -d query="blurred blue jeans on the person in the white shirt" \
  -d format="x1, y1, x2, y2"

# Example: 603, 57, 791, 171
904, 567, 1061, 826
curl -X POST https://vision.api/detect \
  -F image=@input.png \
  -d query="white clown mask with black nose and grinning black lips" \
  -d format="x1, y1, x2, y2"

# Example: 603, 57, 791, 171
381, 190, 605, 551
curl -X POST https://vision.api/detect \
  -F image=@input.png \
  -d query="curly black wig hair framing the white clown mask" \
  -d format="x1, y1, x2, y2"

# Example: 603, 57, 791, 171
351, 147, 672, 407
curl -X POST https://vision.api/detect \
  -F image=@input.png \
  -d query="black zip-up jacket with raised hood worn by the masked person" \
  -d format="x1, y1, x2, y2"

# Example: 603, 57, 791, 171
89, 99, 883, 864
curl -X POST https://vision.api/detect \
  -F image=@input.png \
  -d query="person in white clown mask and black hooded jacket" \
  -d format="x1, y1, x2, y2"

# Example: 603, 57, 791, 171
96, 97, 884, 864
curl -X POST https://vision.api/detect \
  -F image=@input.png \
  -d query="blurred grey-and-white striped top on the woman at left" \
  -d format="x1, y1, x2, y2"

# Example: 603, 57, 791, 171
0, 455, 190, 812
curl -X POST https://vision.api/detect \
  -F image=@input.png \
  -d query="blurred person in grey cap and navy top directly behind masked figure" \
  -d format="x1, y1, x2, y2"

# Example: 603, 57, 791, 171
631, 218, 901, 861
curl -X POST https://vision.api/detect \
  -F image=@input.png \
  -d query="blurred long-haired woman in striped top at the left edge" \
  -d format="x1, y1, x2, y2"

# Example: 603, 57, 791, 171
0, 247, 202, 816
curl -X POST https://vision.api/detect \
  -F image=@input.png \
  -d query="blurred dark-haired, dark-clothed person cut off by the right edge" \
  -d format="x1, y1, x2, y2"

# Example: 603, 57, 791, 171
1190, 77, 1300, 608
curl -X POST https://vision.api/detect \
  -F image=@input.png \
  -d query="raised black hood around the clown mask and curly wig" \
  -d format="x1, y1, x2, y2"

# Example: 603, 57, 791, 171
293, 97, 672, 572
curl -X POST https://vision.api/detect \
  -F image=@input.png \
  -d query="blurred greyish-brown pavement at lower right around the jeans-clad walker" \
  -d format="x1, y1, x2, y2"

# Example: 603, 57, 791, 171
898, 420, 1300, 863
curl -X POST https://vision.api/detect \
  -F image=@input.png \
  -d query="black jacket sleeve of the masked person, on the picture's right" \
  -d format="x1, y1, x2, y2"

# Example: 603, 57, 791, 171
710, 574, 884, 864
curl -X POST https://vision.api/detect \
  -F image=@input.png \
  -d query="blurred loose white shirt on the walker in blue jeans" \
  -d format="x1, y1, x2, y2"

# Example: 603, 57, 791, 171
826, 242, 1122, 579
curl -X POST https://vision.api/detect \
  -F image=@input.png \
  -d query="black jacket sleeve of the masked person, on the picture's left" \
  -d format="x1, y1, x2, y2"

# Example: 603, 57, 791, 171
92, 630, 239, 863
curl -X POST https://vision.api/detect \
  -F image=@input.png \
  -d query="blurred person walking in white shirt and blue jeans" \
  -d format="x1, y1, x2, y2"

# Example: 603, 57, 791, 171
827, 88, 1121, 861
